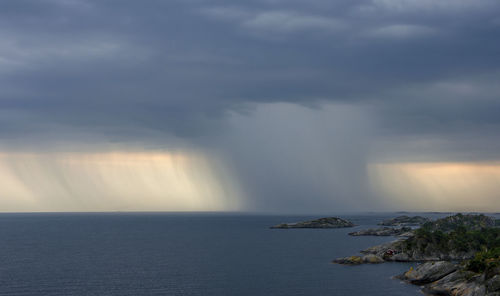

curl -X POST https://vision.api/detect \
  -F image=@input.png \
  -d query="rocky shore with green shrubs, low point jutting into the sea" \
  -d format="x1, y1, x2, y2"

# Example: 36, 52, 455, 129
333, 214, 500, 296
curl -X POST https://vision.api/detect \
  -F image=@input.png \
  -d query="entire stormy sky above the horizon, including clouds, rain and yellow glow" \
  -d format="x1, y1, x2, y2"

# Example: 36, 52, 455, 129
0, 0, 500, 213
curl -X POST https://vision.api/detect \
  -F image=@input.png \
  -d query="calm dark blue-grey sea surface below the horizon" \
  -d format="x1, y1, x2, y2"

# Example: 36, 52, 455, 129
0, 213, 454, 296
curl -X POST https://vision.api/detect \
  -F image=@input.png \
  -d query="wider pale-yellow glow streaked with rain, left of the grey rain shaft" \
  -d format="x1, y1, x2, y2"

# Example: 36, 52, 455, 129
0, 151, 239, 212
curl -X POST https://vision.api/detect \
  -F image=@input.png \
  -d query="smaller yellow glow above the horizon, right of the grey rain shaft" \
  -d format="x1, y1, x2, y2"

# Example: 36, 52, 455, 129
368, 162, 500, 212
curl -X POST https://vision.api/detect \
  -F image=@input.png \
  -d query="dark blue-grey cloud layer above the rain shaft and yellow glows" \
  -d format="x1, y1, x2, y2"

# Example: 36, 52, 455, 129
0, 0, 500, 146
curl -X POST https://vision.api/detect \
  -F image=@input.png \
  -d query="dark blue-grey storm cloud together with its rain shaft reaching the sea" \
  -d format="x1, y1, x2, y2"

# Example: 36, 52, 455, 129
0, 0, 500, 212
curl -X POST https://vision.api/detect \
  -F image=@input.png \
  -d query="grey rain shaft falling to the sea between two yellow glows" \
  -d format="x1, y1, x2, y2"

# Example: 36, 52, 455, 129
205, 103, 375, 213
